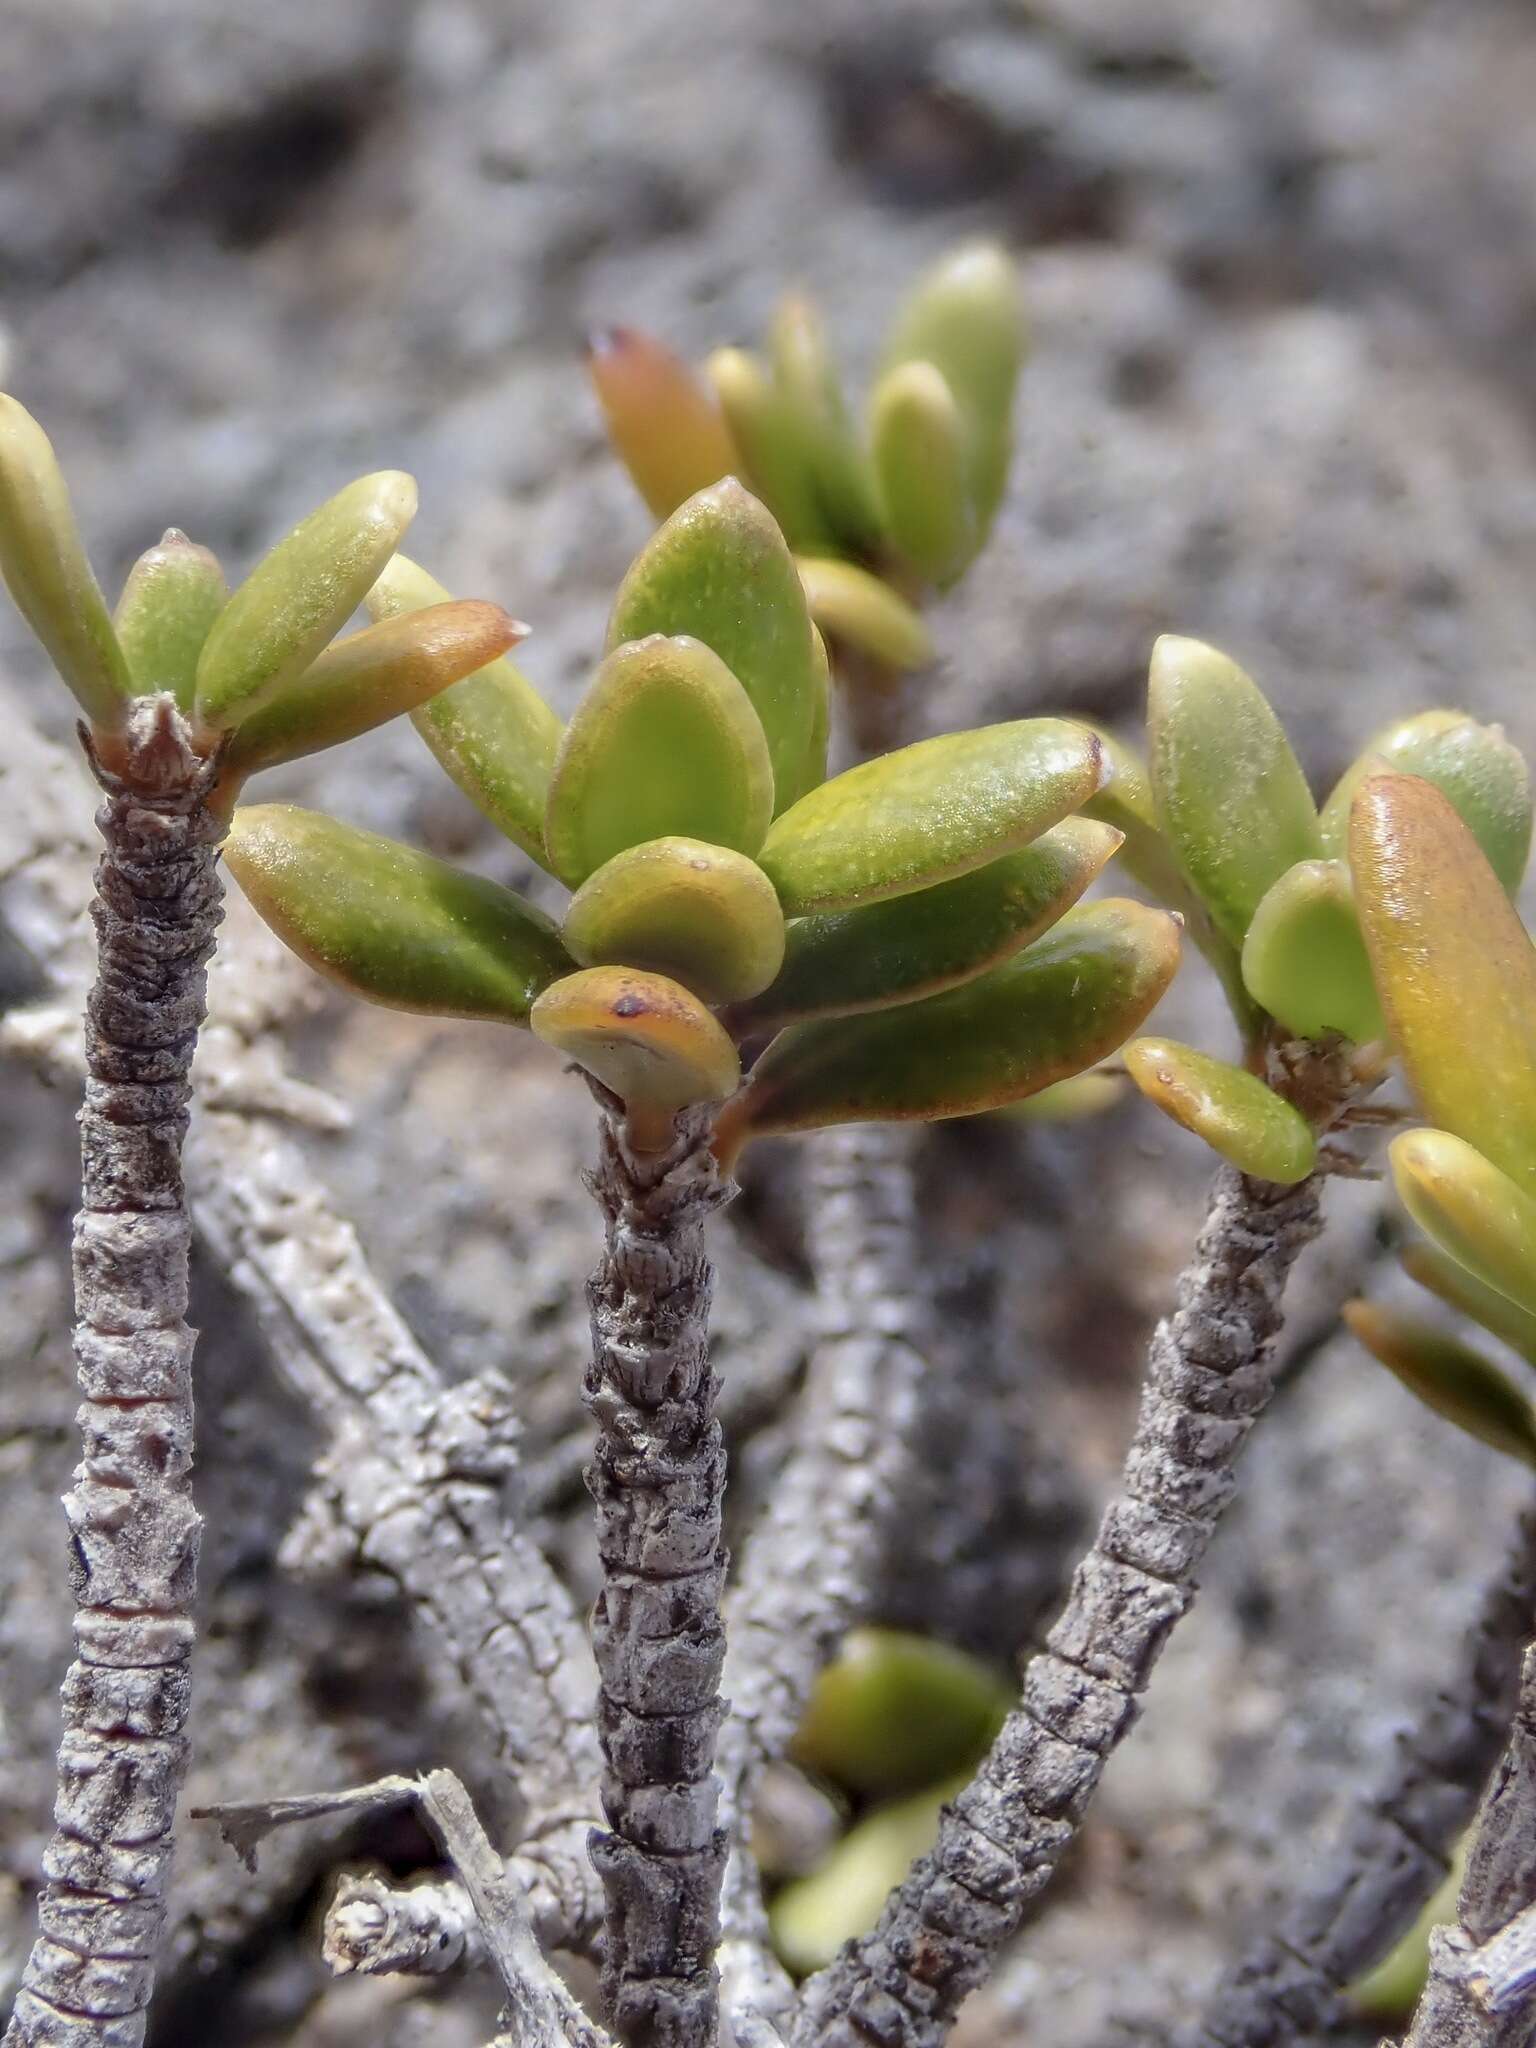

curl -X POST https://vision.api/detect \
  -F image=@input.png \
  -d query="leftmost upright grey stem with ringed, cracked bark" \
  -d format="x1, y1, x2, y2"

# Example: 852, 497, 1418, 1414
6, 696, 223, 2048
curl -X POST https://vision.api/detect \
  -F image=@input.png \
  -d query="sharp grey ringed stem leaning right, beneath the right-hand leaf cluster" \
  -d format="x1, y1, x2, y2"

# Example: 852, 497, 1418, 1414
793, 1167, 1343, 2048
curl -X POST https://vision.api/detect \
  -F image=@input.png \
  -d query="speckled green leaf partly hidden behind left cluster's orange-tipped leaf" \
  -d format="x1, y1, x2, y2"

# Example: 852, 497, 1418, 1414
367, 555, 563, 868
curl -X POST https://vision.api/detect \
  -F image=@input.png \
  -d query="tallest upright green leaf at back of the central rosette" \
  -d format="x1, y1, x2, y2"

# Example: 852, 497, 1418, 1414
608, 477, 819, 806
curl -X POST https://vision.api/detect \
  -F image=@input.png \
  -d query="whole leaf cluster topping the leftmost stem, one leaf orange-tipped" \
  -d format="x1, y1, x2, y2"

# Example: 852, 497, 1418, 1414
0, 397, 524, 790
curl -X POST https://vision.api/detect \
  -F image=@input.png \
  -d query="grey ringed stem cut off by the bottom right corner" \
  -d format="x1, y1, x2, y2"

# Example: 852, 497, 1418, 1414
1405, 1645, 1536, 2048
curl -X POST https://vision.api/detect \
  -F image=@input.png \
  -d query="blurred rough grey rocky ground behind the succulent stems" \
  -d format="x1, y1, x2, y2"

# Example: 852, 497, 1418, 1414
0, 0, 1536, 2048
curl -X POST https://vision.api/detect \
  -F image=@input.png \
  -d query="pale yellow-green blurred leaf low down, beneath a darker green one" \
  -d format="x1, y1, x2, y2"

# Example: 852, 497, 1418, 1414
768, 1772, 969, 1976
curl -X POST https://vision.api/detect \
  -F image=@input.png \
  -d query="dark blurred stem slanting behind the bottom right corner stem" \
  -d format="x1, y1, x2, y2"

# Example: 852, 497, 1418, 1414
1176, 1511, 1536, 2048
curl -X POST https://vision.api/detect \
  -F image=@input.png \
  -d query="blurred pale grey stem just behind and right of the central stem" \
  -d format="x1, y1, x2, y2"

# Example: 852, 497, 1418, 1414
719, 1124, 924, 2013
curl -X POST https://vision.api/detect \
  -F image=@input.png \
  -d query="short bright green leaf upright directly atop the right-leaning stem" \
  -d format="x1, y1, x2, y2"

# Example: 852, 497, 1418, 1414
1243, 860, 1384, 1044
